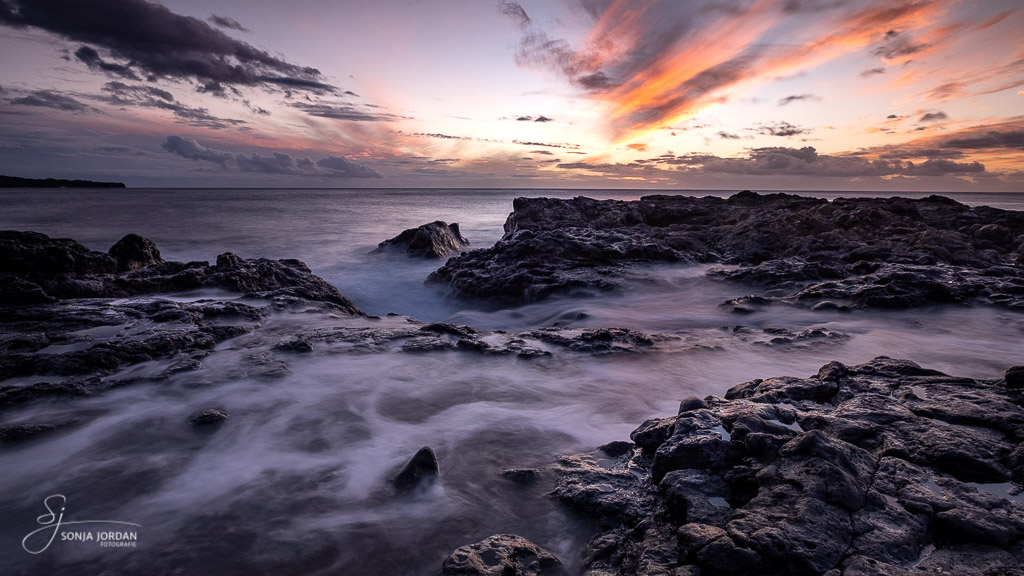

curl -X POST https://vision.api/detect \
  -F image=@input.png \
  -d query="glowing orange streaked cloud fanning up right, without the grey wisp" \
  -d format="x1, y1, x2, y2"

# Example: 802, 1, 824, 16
557, 0, 946, 141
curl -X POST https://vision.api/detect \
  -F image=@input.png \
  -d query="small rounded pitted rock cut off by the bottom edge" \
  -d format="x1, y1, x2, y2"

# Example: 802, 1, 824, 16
441, 534, 565, 576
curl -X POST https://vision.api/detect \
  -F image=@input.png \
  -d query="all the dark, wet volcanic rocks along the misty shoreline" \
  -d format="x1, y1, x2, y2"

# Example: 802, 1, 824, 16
0, 193, 1024, 576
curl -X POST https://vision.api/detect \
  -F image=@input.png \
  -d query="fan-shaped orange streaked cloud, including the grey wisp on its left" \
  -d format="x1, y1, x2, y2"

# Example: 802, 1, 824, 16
507, 0, 942, 139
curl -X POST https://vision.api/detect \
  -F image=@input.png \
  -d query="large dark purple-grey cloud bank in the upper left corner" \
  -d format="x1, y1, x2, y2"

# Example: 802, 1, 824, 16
0, 0, 334, 91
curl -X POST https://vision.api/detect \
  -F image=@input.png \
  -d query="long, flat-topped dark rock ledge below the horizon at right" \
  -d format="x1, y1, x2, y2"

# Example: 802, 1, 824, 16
427, 192, 1024, 312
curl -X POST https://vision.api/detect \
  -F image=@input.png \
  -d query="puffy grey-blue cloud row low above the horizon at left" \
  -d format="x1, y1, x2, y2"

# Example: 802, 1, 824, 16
161, 135, 384, 178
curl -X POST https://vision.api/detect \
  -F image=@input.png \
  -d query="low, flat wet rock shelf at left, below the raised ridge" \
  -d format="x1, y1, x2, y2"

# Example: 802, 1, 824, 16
0, 299, 265, 407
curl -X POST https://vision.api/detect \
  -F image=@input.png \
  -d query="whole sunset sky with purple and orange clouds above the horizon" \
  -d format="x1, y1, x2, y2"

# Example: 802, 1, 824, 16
0, 0, 1024, 192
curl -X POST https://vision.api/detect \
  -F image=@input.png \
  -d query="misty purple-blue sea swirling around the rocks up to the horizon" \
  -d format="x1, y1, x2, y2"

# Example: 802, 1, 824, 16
0, 189, 1024, 576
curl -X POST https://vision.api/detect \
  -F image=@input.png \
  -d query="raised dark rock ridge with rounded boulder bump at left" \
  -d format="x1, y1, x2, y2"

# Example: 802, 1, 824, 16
0, 231, 362, 315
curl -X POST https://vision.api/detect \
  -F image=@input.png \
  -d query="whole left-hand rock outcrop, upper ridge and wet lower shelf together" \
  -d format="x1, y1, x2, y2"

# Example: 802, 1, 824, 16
0, 231, 362, 407
